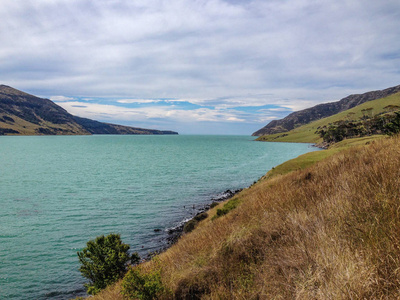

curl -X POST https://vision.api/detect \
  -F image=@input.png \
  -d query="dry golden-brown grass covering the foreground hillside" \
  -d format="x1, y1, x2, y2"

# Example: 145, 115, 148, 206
94, 137, 400, 299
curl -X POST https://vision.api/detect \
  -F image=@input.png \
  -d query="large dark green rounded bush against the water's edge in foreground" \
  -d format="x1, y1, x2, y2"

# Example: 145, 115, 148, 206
78, 233, 139, 295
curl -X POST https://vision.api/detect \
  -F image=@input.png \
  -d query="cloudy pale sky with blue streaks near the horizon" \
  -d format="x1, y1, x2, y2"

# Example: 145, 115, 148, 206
0, 0, 400, 135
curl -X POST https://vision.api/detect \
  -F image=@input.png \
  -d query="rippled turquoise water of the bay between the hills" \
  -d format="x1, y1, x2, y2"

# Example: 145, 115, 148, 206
0, 136, 317, 299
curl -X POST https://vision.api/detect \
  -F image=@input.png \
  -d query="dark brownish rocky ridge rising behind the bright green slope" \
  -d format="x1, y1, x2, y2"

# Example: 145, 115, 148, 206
252, 85, 400, 136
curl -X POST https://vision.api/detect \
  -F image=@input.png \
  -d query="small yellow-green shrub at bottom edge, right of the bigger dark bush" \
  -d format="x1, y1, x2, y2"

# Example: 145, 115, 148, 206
122, 266, 165, 300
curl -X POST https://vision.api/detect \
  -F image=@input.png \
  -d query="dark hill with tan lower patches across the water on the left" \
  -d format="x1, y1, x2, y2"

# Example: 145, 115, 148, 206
0, 85, 177, 135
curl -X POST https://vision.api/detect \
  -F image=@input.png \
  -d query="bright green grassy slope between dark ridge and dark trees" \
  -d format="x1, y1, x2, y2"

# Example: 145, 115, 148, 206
257, 93, 400, 143
